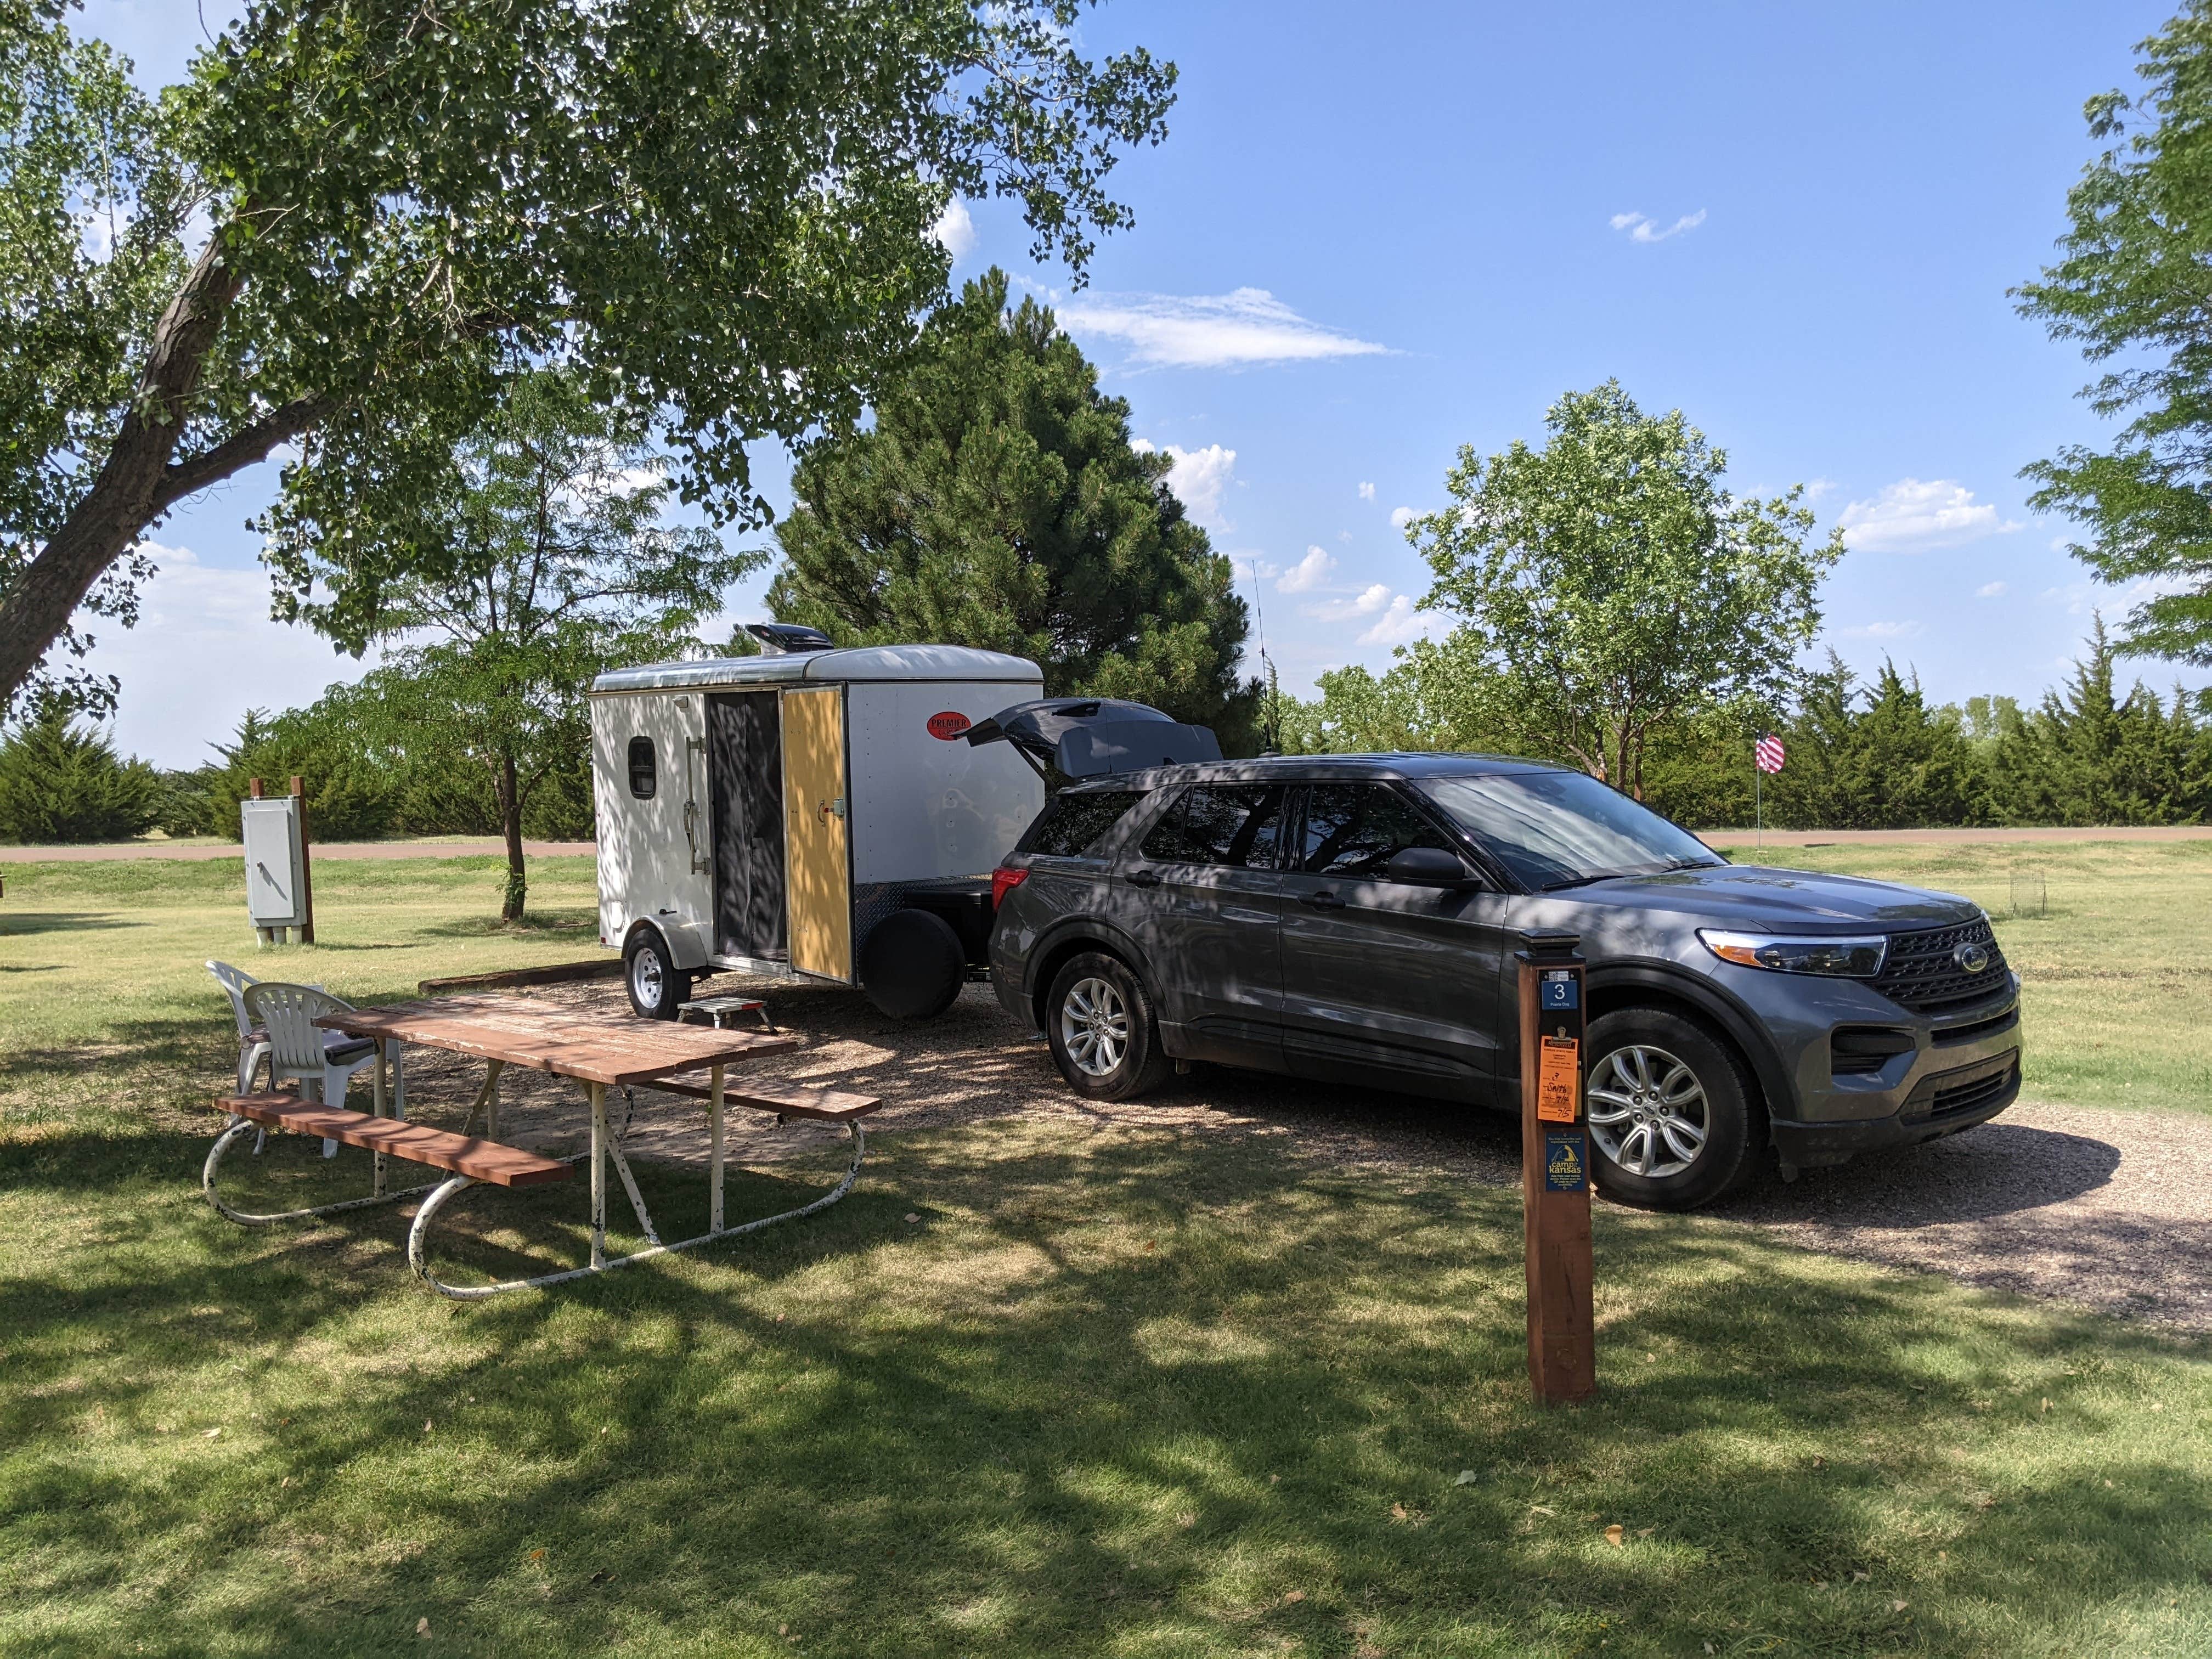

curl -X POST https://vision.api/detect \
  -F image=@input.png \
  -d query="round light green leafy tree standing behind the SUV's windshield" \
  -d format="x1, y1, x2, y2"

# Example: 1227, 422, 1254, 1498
1407, 381, 1843, 797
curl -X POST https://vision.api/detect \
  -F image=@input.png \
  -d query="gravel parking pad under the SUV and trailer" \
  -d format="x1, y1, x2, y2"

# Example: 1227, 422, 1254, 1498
407, 975, 2212, 1331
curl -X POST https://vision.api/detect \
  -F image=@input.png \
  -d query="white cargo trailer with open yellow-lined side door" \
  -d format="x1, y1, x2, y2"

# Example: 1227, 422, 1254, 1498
591, 641, 1044, 1018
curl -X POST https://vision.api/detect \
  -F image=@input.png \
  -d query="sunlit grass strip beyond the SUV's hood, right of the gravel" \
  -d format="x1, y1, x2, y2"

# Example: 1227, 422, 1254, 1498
1730, 840, 2212, 1110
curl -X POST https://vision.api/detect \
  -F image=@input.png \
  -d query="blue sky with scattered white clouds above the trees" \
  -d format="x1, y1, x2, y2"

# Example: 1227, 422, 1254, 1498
82, 0, 2212, 765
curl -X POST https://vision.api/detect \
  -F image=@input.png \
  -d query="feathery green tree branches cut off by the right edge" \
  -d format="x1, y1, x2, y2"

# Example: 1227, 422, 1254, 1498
2013, 0, 2212, 664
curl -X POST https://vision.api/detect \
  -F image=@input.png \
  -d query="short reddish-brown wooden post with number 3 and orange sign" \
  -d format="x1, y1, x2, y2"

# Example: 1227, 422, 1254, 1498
1515, 931, 1597, 1404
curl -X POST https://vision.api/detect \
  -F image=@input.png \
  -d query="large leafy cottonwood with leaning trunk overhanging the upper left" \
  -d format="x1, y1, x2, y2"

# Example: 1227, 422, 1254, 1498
0, 0, 1175, 701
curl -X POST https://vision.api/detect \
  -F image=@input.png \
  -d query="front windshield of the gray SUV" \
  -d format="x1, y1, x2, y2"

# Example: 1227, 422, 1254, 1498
1418, 772, 1728, 889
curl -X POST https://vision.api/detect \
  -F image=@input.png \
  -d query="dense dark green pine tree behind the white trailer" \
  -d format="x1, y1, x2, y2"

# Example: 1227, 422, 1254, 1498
768, 270, 1259, 752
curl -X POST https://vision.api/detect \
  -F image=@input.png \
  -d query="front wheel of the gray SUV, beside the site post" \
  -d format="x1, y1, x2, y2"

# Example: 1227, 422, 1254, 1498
1586, 1009, 1756, 1210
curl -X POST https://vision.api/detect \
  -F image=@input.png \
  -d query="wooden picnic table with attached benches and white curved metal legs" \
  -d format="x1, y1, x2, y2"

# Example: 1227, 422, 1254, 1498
204, 995, 881, 1299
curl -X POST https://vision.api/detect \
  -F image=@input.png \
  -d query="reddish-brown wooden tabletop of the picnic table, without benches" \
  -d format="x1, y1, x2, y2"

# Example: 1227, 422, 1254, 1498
317, 995, 799, 1084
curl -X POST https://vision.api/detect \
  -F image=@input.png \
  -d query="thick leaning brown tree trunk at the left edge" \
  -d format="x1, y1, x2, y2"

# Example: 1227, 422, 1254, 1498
0, 232, 239, 701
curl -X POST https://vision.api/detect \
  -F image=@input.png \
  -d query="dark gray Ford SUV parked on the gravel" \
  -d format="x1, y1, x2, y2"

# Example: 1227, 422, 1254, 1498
991, 754, 2019, 1207
